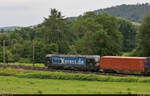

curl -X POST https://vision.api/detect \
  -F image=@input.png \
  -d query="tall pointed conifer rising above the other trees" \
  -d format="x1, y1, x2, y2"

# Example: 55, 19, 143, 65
41, 9, 69, 53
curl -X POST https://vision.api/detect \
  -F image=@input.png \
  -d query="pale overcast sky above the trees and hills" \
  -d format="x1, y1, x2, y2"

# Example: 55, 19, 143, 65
0, 0, 150, 27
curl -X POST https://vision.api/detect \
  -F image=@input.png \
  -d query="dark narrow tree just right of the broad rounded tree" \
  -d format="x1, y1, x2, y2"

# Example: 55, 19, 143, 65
118, 19, 137, 52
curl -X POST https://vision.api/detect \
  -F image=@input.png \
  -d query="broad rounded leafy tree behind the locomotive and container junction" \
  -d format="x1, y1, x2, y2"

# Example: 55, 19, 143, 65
71, 14, 122, 56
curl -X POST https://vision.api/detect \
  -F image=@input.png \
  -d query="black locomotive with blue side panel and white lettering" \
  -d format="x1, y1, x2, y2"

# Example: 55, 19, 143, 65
45, 54, 100, 71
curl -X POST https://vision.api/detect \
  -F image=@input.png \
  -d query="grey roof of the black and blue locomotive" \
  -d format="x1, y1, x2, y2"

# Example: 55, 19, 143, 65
46, 54, 100, 58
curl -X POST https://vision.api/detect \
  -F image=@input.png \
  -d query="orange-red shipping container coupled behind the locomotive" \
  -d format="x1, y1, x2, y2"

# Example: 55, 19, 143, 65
100, 56, 147, 72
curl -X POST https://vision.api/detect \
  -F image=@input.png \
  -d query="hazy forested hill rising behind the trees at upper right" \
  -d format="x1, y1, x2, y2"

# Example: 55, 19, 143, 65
95, 3, 150, 22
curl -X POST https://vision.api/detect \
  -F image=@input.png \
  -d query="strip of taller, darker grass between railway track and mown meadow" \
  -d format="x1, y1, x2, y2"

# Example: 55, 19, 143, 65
0, 68, 150, 83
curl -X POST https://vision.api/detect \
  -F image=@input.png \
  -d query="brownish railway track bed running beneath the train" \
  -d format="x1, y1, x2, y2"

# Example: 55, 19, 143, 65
0, 64, 150, 77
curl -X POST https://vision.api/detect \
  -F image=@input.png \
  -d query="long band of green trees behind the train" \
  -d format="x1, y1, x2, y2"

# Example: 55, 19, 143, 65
0, 9, 150, 63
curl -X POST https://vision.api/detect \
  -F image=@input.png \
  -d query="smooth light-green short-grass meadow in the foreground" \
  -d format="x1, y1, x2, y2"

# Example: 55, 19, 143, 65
0, 76, 150, 94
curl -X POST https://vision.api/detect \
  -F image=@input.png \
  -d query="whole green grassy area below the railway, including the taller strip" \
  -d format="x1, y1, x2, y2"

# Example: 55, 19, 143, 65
0, 68, 150, 94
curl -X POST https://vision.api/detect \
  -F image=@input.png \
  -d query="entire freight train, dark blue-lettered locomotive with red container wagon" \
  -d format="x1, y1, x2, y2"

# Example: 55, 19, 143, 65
45, 54, 150, 73
